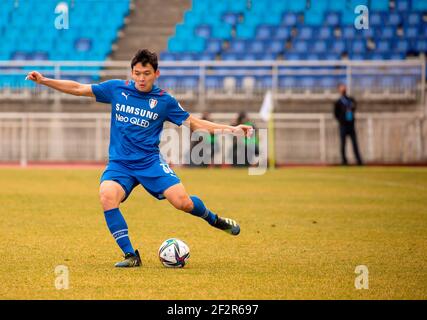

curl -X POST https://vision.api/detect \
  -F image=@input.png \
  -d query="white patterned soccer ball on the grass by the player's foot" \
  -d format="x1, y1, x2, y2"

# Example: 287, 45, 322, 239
159, 238, 190, 268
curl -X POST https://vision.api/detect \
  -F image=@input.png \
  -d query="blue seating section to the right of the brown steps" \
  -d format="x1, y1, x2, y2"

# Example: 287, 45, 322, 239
161, 0, 427, 99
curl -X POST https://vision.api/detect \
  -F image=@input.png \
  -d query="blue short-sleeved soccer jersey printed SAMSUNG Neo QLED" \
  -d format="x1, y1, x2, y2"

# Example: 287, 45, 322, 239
92, 80, 189, 167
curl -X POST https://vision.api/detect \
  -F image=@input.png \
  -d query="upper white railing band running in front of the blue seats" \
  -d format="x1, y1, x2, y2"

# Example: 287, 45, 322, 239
0, 55, 426, 109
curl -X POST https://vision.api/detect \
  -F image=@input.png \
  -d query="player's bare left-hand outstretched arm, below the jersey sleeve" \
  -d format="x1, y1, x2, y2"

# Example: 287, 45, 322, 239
26, 71, 95, 97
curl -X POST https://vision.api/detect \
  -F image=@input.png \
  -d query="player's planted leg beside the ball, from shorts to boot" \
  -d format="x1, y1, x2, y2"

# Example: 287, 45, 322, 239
99, 168, 141, 267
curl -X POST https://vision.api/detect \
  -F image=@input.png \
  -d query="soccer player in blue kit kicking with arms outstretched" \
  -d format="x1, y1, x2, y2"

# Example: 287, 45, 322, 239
27, 49, 252, 267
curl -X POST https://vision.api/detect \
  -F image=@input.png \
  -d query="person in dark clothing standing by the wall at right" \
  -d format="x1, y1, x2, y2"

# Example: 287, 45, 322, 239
334, 84, 363, 165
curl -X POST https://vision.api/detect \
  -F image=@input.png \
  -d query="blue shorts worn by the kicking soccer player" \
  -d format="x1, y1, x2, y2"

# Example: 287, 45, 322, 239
101, 158, 181, 201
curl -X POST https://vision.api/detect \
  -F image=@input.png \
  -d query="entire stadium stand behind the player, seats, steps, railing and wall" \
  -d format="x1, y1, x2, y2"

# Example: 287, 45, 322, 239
0, 0, 427, 163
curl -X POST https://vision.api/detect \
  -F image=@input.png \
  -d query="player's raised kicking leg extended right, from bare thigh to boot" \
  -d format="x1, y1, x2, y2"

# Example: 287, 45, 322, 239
163, 183, 240, 235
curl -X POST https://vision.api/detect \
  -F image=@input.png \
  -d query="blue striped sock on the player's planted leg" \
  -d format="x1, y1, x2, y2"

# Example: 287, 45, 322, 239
104, 208, 135, 254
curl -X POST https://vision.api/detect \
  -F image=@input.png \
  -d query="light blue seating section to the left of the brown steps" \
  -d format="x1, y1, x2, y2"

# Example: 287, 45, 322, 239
0, 0, 130, 87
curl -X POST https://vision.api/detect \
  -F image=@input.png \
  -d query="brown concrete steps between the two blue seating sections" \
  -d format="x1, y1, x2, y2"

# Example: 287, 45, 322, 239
111, 0, 191, 60
